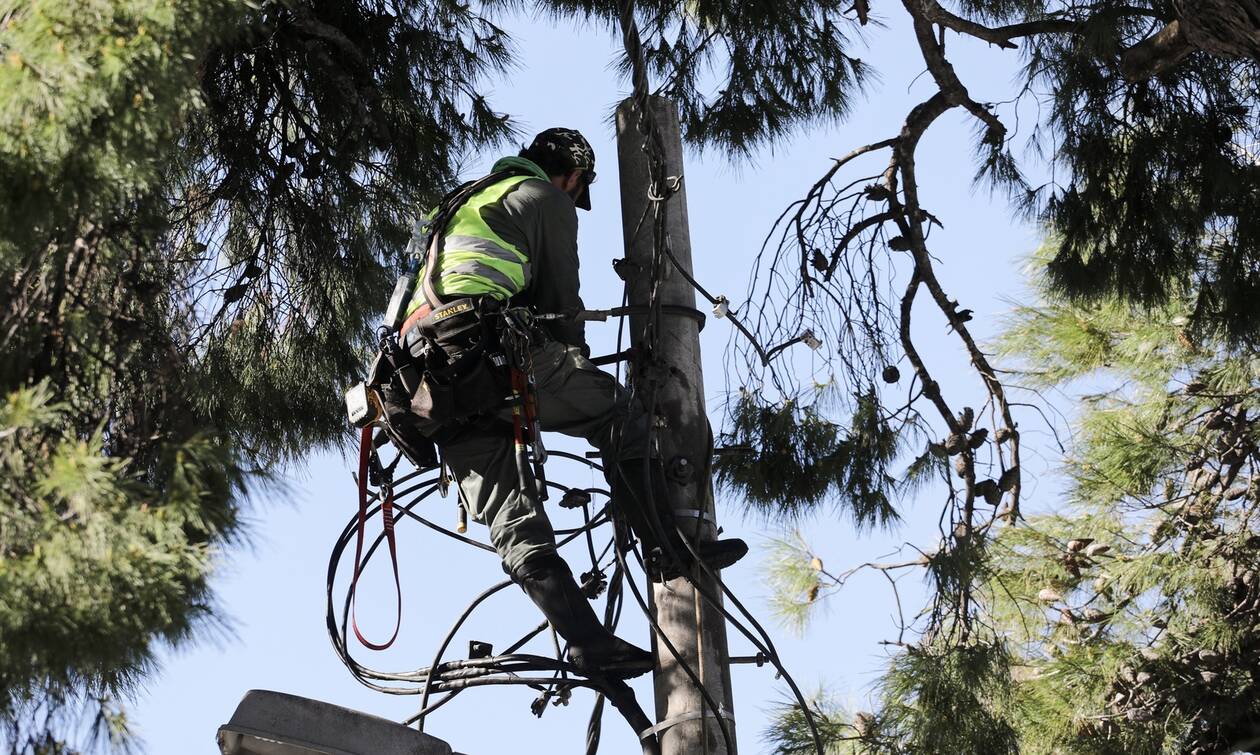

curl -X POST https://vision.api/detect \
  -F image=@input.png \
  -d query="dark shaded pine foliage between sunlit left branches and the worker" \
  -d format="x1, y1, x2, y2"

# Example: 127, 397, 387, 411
166, 0, 512, 456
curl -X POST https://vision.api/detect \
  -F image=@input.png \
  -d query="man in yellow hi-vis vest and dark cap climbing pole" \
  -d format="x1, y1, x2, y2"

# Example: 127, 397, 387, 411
402, 129, 747, 677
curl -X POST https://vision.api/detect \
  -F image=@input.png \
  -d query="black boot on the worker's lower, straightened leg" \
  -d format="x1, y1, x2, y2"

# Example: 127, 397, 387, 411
514, 555, 655, 678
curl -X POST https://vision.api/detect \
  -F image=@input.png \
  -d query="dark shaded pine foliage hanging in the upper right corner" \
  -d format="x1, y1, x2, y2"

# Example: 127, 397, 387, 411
1028, 3, 1260, 343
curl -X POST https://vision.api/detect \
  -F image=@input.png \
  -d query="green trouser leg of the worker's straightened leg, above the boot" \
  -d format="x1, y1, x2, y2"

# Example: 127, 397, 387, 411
442, 422, 556, 573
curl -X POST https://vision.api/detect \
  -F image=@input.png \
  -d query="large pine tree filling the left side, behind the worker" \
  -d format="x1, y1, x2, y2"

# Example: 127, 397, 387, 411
0, 0, 510, 754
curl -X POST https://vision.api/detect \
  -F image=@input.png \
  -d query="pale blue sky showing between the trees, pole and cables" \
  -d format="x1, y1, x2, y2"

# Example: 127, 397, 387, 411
132, 6, 1057, 755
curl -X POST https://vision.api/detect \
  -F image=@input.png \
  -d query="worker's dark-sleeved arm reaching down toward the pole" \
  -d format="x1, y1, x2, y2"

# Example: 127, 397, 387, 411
493, 180, 590, 355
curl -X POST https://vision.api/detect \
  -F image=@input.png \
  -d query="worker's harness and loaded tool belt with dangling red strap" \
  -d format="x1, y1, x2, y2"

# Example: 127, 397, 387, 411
345, 169, 546, 650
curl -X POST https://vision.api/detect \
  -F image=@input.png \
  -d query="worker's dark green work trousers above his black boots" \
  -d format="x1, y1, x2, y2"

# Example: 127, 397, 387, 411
441, 342, 649, 573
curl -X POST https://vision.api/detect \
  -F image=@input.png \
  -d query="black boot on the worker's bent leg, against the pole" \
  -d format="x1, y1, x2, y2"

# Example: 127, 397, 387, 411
611, 459, 748, 582
